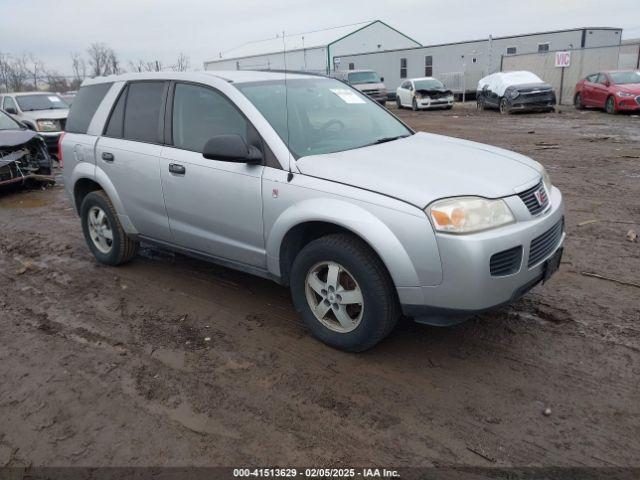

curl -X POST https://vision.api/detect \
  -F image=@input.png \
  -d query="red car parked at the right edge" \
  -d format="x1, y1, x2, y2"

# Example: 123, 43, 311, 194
573, 70, 640, 113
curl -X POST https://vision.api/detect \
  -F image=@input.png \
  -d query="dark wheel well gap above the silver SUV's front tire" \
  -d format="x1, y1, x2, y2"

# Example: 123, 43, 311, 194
280, 221, 391, 285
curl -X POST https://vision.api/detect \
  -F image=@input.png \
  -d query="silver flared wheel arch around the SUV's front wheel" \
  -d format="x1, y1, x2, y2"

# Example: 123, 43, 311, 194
266, 198, 420, 287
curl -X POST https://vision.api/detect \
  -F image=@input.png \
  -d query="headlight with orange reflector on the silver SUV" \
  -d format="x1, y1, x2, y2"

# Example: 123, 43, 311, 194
426, 197, 515, 233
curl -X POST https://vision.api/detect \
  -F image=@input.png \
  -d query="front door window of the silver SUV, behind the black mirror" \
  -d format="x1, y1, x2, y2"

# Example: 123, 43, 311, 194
172, 83, 253, 152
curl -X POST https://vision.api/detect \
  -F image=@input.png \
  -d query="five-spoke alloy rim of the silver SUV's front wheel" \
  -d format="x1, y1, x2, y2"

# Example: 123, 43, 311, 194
305, 261, 364, 333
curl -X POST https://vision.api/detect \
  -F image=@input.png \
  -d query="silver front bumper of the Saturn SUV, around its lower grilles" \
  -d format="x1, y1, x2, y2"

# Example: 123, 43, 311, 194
398, 188, 565, 325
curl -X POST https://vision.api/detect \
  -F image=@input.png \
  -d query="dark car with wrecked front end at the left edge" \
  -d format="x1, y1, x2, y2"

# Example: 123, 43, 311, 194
0, 110, 54, 187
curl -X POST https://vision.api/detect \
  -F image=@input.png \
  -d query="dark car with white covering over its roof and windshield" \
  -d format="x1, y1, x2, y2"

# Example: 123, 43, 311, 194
476, 71, 556, 114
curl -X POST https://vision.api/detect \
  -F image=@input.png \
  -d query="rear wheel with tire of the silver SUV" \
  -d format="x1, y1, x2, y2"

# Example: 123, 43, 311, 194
80, 190, 137, 266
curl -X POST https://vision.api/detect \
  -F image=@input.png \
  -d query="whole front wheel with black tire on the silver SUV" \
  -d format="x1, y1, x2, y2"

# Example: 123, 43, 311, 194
291, 234, 400, 352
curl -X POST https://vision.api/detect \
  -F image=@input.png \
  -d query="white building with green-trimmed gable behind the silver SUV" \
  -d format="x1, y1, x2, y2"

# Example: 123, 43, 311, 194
204, 20, 421, 73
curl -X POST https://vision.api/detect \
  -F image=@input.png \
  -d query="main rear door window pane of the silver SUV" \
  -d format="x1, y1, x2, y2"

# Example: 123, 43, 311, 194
122, 82, 166, 143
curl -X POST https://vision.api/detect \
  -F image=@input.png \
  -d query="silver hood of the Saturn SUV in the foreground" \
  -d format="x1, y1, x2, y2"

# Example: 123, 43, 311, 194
297, 132, 542, 208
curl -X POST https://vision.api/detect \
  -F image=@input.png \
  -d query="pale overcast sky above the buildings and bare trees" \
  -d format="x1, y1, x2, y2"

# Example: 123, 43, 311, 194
0, 0, 640, 74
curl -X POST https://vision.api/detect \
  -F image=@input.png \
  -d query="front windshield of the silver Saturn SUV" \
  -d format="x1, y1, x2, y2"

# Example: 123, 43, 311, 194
236, 77, 412, 158
